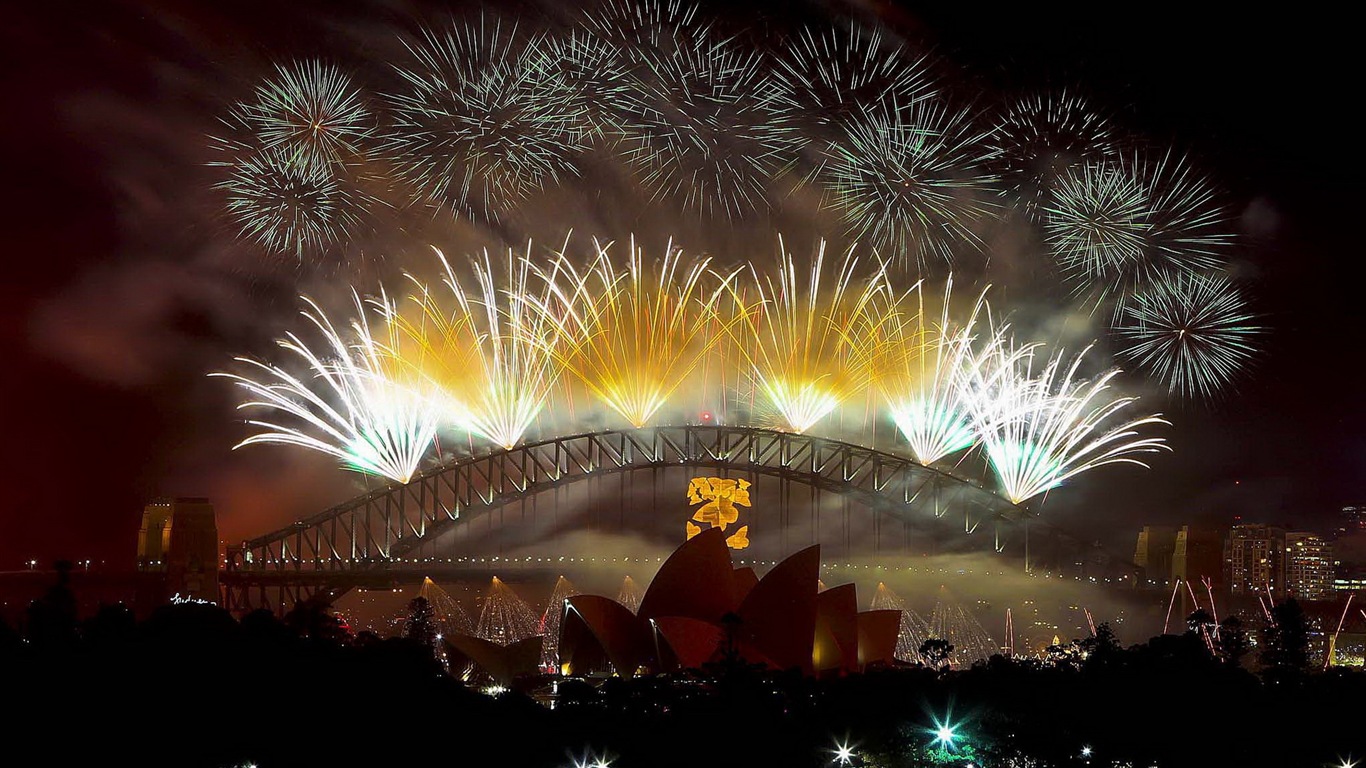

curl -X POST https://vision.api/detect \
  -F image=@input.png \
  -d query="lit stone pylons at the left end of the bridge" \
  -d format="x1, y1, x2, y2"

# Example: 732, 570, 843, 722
138, 499, 219, 603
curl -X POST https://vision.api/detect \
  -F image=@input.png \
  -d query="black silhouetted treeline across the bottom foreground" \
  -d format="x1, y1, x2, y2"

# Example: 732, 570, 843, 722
0, 573, 1366, 768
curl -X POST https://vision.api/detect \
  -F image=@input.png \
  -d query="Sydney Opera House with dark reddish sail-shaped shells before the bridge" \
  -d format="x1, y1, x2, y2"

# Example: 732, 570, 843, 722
445, 527, 902, 682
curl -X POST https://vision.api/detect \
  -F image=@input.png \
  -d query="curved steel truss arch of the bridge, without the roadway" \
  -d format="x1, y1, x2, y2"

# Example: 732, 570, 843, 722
223, 425, 1029, 611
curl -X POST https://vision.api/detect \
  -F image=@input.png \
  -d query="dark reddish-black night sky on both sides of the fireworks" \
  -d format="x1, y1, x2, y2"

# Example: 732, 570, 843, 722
0, 0, 1366, 571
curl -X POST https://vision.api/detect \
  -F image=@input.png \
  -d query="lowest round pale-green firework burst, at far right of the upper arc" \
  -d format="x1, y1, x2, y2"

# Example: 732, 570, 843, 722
1115, 273, 1261, 398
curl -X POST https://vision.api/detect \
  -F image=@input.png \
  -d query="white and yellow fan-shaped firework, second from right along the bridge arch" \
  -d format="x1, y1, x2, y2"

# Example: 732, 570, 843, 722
877, 277, 986, 465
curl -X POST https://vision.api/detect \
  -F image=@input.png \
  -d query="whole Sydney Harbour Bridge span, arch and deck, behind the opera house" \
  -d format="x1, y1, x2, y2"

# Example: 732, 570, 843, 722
220, 425, 1126, 611
